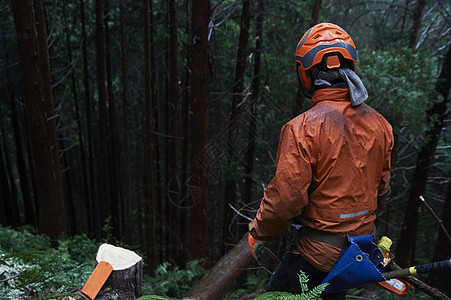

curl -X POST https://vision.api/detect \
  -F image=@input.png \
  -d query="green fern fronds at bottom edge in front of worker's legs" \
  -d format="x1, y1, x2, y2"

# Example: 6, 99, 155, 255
255, 270, 329, 300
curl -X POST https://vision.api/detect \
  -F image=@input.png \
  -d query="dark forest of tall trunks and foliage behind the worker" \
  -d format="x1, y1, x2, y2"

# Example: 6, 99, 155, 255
0, 0, 451, 298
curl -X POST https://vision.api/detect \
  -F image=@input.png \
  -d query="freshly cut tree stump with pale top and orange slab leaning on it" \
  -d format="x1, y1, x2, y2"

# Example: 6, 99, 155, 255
82, 244, 143, 300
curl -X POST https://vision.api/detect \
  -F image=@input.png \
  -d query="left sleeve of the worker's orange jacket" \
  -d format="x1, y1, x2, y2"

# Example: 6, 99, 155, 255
249, 122, 312, 240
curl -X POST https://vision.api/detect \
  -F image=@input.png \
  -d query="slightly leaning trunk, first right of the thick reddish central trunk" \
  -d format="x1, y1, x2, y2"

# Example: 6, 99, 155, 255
222, 0, 251, 243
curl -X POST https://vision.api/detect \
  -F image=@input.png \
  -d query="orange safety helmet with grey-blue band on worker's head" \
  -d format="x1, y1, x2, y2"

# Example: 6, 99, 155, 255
296, 23, 358, 95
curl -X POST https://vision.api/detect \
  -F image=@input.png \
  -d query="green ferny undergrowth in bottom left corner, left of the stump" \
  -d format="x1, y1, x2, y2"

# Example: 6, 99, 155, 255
0, 227, 97, 299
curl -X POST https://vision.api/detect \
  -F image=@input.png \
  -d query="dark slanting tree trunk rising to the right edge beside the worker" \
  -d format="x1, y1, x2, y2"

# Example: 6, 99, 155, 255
396, 47, 451, 267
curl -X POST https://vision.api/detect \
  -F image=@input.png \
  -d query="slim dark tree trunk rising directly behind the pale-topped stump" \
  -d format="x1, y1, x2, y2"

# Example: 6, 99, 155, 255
119, 3, 132, 243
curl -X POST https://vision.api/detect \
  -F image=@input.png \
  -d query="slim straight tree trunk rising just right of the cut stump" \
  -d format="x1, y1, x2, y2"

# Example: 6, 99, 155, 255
143, 0, 157, 270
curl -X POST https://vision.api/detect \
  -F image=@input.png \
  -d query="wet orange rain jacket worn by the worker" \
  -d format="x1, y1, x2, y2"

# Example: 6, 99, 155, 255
249, 88, 393, 272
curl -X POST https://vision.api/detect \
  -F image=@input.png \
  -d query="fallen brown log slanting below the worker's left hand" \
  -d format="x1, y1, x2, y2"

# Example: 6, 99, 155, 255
183, 234, 252, 300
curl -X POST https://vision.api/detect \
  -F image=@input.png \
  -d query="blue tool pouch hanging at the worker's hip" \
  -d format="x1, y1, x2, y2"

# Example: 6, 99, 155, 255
322, 235, 385, 293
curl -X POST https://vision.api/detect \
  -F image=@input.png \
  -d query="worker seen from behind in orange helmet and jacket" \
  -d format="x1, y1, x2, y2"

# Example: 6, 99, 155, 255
248, 23, 394, 299
